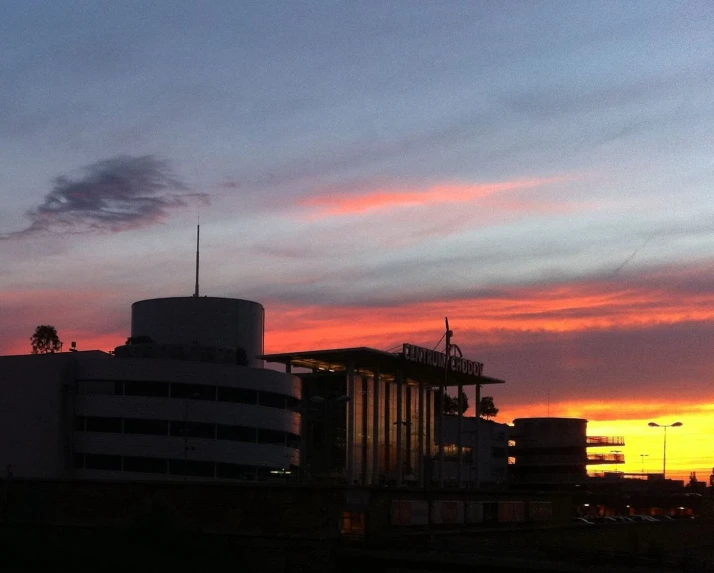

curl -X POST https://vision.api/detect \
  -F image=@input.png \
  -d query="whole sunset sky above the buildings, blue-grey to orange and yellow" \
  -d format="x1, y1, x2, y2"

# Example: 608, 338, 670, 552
0, 0, 714, 479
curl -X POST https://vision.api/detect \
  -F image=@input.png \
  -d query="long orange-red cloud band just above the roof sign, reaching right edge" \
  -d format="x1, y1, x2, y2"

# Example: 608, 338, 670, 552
266, 269, 714, 351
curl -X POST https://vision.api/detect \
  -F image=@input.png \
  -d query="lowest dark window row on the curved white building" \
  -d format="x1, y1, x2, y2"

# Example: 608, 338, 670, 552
74, 454, 289, 481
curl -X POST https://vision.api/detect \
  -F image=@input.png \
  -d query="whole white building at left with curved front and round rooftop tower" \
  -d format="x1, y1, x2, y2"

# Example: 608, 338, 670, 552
0, 297, 301, 480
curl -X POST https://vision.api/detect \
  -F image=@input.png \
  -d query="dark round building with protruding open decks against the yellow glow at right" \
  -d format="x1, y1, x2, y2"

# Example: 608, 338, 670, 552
509, 418, 625, 486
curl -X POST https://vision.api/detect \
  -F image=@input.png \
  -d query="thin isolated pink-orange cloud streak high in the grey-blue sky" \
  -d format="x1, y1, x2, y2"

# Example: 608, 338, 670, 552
300, 177, 568, 217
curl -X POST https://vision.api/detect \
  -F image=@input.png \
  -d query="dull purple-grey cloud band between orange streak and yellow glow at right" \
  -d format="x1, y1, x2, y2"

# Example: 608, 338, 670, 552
472, 321, 714, 408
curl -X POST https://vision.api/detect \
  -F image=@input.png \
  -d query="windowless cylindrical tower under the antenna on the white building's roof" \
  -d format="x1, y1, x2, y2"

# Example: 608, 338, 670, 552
131, 297, 265, 366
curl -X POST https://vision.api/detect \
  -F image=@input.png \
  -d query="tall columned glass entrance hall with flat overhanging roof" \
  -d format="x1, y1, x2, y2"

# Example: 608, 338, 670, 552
263, 344, 503, 487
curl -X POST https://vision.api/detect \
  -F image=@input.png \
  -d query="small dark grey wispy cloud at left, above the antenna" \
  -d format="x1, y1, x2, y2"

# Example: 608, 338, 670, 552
2, 155, 208, 239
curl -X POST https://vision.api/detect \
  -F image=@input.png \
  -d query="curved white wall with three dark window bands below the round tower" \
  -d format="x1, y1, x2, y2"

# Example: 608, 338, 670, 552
72, 358, 301, 480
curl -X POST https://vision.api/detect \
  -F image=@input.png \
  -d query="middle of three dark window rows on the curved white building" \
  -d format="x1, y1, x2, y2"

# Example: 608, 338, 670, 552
74, 416, 300, 448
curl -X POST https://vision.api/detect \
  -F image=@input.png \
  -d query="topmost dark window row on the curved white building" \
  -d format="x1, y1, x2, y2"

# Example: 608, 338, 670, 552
77, 380, 300, 410
